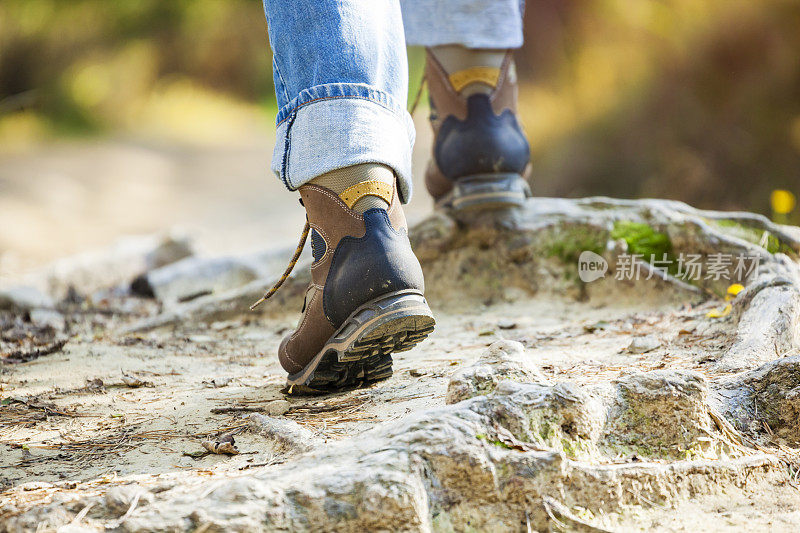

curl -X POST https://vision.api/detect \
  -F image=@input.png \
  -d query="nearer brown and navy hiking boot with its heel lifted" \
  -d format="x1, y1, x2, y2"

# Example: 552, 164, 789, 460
255, 181, 435, 393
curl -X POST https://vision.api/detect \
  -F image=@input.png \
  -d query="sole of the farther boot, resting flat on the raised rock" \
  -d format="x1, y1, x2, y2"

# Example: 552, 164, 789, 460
436, 173, 533, 213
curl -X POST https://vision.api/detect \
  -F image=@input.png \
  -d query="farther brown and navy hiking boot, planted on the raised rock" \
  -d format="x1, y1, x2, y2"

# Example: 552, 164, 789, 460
425, 51, 531, 212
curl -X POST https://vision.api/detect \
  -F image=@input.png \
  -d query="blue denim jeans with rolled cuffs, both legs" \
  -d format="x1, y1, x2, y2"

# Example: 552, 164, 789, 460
264, 0, 522, 201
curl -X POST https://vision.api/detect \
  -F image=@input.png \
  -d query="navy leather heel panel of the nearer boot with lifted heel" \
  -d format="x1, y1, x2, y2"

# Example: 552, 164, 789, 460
323, 208, 424, 328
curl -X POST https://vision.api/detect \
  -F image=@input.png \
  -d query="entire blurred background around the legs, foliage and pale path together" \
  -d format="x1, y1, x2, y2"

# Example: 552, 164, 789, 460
0, 0, 800, 282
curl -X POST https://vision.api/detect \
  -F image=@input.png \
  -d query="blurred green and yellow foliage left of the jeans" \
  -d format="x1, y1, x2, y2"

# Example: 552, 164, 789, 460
0, 0, 274, 133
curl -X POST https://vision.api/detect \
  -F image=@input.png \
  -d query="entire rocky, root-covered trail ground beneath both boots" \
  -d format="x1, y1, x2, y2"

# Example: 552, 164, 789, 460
0, 198, 800, 532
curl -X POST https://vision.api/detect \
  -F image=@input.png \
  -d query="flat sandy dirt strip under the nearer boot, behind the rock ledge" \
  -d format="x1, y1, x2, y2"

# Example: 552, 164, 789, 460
0, 298, 684, 485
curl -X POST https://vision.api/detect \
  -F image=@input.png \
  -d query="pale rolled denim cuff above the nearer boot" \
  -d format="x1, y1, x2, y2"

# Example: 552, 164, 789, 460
271, 83, 415, 202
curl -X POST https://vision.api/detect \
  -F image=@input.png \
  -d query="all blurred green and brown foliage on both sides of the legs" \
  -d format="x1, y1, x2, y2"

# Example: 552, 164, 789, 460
0, 0, 800, 216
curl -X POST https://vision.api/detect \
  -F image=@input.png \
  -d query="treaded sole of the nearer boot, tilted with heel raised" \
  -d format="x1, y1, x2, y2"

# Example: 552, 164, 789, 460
284, 290, 436, 394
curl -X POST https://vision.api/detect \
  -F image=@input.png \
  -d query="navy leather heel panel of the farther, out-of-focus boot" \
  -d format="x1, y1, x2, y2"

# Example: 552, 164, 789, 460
434, 94, 531, 179
